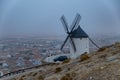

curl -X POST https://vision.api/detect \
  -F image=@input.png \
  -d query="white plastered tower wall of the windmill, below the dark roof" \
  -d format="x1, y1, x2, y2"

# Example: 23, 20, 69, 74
70, 38, 89, 59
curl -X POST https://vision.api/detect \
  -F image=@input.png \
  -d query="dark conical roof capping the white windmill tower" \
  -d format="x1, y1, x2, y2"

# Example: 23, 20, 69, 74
71, 26, 88, 38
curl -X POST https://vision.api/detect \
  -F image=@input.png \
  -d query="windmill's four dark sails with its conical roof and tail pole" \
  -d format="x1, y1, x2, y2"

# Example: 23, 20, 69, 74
61, 14, 99, 51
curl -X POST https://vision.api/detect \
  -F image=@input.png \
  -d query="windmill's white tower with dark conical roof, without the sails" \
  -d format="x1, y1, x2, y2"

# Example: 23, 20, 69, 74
70, 26, 89, 58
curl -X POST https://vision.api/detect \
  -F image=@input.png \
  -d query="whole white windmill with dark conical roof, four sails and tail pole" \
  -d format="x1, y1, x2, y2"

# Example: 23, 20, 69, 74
61, 14, 99, 58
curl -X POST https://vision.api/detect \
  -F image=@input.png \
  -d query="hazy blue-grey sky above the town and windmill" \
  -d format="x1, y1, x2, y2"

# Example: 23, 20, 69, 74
0, 0, 120, 36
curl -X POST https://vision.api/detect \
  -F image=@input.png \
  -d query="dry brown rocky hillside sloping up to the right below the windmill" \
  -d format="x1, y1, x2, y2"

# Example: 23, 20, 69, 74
1, 43, 120, 80
